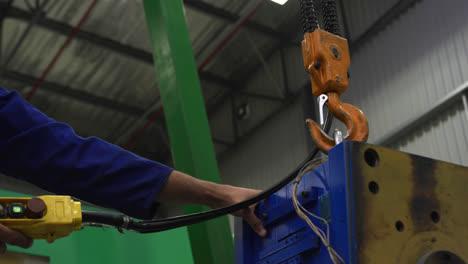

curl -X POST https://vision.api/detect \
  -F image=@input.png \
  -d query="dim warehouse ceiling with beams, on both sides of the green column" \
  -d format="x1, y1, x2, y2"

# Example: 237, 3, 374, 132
0, 0, 414, 164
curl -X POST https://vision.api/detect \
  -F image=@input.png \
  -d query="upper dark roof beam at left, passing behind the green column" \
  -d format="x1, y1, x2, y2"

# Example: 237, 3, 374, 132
6, 7, 230, 85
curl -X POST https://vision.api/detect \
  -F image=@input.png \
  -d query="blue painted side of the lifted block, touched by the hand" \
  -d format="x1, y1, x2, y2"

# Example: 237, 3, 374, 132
235, 142, 356, 264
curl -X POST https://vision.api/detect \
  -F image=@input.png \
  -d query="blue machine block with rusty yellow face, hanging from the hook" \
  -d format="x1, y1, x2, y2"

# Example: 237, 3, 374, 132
235, 141, 468, 264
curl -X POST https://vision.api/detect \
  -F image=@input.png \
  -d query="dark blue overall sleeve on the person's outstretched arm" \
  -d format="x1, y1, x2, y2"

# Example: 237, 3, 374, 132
0, 87, 173, 219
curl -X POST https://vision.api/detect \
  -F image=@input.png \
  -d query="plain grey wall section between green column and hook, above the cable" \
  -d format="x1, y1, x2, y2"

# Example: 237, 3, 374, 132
220, 94, 310, 189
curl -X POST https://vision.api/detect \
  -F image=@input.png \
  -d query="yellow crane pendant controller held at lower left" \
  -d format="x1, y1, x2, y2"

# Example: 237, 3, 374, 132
0, 195, 82, 243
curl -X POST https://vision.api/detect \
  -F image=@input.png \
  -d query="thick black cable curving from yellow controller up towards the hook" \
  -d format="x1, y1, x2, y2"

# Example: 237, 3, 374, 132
82, 112, 332, 233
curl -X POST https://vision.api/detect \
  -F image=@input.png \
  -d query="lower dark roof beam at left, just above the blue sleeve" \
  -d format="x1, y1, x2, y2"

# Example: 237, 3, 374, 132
3, 70, 145, 116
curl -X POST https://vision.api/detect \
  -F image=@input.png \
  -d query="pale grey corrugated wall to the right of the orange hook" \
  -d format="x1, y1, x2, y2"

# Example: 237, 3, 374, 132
344, 0, 468, 166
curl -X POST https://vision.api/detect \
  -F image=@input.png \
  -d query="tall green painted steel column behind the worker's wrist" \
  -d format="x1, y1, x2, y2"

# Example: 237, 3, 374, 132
144, 0, 234, 264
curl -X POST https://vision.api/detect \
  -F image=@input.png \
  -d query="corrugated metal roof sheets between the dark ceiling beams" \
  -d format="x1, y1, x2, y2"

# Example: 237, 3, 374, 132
2, 0, 272, 161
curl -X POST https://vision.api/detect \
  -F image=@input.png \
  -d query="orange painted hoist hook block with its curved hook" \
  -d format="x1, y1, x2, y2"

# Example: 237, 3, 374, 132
302, 29, 369, 153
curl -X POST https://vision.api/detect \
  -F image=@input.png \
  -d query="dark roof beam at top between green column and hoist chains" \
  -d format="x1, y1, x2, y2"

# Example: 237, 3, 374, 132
184, 0, 297, 44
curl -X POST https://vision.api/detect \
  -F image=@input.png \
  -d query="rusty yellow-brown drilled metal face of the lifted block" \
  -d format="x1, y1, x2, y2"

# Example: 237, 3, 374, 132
350, 143, 468, 264
